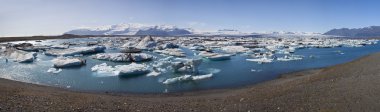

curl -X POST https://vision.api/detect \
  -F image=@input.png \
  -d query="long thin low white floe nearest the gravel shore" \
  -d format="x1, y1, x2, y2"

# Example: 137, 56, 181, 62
162, 73, 213, 84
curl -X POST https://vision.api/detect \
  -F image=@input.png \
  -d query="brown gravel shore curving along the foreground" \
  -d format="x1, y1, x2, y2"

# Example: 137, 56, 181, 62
0, 53, 380, 112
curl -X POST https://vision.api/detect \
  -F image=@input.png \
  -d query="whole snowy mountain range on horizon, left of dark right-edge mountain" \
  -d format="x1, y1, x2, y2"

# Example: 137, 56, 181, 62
64, 23, 321, 36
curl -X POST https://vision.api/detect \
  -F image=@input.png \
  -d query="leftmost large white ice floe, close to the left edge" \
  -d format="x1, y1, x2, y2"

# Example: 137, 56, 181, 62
8, 50, 37, 63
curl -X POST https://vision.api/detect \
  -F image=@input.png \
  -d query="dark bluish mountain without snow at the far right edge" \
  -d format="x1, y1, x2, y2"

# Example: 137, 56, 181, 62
324, 26, 380, 37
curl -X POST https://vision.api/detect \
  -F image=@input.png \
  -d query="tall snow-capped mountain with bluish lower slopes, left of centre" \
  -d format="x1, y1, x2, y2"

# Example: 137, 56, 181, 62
64, 23, 191, 36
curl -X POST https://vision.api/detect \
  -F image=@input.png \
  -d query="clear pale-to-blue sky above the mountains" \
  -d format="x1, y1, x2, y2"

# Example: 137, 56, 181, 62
0, 0, 380, 36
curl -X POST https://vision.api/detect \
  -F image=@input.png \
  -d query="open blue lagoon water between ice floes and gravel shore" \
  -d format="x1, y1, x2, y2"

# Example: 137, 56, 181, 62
0, 39, 380, 93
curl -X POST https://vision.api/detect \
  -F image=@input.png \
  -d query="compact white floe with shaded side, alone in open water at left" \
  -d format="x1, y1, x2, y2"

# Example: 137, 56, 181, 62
52, 57, 86, 68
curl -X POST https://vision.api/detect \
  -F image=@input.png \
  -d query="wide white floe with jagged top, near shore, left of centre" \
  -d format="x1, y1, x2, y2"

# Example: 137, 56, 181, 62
91, 63, 150, 76
